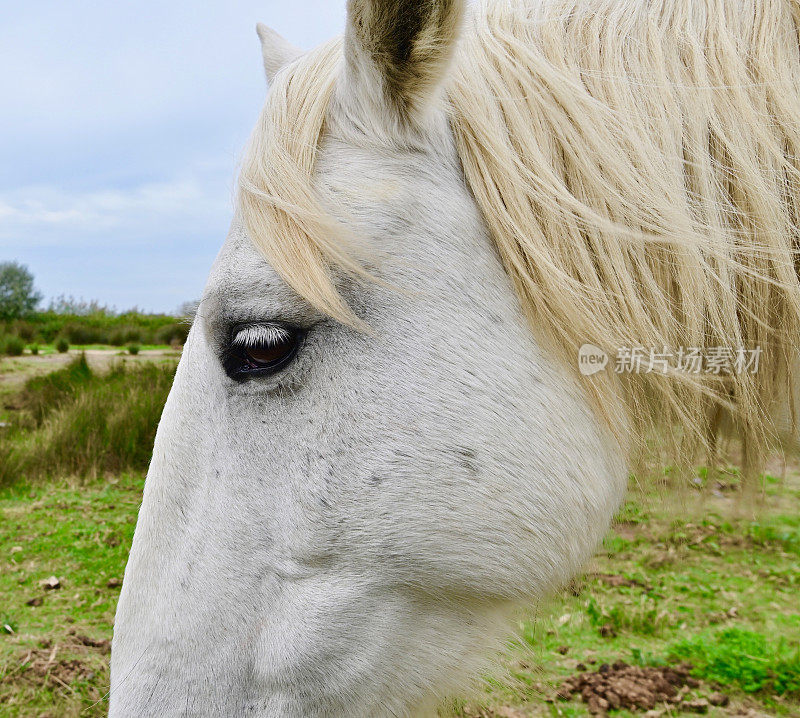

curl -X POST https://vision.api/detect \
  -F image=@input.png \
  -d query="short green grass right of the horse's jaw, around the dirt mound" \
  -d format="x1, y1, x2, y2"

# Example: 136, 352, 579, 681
448, 492, 800, 718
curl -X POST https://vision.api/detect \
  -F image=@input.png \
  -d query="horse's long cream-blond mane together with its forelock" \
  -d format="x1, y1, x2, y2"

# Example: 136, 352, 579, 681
240, 0, 800, 480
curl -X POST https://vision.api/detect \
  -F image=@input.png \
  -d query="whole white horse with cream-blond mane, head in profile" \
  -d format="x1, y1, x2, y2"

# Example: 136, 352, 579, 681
110, 0, 800, 718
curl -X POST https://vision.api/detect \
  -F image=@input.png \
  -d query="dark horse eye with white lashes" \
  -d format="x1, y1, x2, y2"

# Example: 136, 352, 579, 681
223, 324, 302, 379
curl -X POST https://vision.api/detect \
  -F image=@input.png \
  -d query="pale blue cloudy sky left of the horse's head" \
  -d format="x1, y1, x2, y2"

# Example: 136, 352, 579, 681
0, 0, 345, 311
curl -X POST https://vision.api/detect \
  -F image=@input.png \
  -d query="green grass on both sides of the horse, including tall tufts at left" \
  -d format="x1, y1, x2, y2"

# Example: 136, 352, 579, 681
0, 357, 800, 718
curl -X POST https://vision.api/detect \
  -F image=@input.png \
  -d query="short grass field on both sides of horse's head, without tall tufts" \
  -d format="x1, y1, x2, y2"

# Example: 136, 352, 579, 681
0, 358, 800, 718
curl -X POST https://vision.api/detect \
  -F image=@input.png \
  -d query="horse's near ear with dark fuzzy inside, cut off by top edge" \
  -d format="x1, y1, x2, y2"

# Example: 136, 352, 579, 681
345, 0, 465, 124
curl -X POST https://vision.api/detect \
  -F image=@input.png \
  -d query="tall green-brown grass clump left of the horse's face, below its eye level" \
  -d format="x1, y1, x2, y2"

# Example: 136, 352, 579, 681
0, 356, 175, 484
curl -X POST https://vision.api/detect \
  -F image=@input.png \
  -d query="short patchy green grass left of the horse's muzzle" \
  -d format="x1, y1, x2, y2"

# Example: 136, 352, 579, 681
0, 475, 143, 718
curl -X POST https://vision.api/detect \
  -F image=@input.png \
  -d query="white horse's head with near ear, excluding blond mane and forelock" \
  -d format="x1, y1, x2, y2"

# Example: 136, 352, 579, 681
111, 2, 625, 718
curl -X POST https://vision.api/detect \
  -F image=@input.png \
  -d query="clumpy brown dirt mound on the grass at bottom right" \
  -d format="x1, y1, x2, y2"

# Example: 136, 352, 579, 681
557, 661, 720, 715
